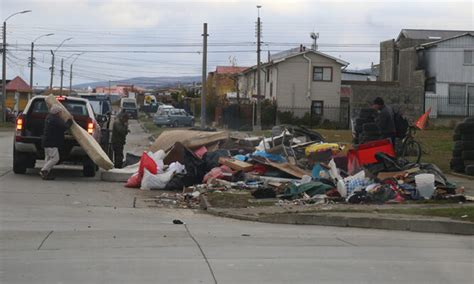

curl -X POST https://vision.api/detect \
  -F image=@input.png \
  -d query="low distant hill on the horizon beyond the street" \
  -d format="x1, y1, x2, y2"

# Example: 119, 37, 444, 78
74, 76, 201, 89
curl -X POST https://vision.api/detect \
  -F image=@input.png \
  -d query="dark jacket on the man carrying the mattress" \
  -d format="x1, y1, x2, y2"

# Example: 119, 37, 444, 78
43, 113, 72, 148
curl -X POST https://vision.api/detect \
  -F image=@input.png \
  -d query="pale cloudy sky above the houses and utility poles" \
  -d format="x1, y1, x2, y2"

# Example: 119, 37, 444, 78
0, 0, 474, 86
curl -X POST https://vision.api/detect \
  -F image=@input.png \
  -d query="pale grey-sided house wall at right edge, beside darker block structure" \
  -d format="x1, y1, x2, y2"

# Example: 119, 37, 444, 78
417, 32, 474, 117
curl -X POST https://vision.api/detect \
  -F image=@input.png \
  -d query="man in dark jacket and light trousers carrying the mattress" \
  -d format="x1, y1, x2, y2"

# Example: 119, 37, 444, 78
40, 105, 72, 180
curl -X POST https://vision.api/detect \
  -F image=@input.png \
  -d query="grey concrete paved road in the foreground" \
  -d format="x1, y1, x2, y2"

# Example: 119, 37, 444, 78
0, 125, 474, 284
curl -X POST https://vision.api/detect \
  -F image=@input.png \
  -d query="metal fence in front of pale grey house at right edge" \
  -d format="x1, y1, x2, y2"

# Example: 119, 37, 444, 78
425, 95, 474, 118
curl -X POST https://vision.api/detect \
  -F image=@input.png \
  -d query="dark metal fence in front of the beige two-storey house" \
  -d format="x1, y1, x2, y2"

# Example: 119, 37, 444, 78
222, 103, 350, 130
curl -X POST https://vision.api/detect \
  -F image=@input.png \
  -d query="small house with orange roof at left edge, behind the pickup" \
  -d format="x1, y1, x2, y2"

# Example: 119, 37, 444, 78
0, 76, 32, 111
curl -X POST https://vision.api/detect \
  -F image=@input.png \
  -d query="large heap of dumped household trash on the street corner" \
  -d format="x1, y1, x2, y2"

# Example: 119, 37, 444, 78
121, 125, 466, 208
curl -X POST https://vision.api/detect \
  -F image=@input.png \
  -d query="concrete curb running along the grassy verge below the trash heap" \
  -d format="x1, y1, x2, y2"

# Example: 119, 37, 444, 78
205, 197, 474, 235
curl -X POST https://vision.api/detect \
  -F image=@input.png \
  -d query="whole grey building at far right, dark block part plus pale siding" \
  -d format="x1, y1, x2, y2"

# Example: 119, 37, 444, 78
376, 29, 474, 117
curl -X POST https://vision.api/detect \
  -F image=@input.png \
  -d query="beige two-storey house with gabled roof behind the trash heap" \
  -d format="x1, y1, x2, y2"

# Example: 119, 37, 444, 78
238, 46, 349, 120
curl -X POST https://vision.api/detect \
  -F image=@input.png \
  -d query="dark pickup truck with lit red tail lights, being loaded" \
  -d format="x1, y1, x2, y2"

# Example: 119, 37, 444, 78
13, 96, 101, 177
